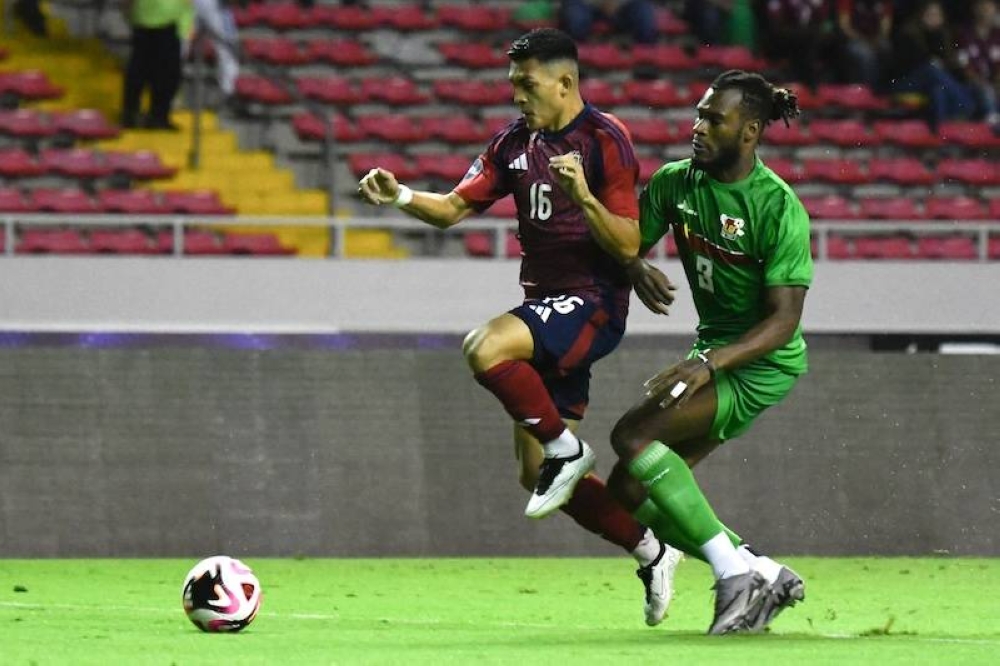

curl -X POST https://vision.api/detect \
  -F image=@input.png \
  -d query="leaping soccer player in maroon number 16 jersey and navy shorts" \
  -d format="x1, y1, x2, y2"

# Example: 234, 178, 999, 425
358, 28, 680, 625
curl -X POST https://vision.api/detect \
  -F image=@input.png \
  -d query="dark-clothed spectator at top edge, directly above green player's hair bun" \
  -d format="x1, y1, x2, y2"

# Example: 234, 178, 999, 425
758, 0, 833, 89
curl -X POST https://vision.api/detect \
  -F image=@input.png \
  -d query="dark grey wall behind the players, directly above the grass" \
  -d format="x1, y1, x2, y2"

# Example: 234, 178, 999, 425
0, 343, 1000, 557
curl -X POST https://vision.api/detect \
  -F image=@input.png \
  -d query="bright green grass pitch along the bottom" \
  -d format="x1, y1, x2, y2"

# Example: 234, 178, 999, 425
0, 556, 1000, 666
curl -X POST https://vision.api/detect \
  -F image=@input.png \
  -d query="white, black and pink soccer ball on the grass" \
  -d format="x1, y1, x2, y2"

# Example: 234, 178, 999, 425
181, 555, 260, 632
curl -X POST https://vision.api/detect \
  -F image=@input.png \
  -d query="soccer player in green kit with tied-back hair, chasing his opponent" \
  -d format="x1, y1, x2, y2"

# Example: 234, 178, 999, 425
610, 71, 813, 634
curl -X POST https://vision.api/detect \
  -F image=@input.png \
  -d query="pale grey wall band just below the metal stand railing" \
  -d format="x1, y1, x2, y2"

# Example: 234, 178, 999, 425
0, 257, 1000, 335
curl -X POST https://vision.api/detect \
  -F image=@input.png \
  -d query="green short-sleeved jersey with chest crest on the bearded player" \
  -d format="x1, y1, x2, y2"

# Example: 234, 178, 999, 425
639, 159, 813, 375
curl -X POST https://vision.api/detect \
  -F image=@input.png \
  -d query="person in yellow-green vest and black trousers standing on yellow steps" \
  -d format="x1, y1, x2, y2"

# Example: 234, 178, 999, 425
122, 0, 194, 130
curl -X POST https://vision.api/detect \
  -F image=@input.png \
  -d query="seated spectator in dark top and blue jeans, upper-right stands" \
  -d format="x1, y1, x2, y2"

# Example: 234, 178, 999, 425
890, 0, 976, 129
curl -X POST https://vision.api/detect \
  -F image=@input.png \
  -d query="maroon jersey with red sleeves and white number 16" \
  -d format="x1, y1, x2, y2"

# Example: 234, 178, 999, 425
455, 104, 639, 321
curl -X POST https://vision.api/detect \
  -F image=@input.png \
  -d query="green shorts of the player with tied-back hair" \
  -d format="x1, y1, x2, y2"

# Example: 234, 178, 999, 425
691, 350, 798, 442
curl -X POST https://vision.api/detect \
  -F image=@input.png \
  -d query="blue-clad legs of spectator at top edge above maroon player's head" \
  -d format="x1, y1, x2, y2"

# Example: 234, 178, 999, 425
559, 0, 659, 44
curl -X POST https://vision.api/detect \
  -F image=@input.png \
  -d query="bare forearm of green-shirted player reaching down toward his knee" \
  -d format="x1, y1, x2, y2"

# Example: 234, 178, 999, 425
708, 287, 807, 369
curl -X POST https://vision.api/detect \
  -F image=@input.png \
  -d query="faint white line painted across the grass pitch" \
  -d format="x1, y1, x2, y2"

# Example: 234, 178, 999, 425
0, 601, 1000, 646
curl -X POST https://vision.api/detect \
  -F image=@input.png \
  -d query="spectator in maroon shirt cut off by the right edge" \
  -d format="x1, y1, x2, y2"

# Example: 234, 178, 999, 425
958, 0, 1000, 130
